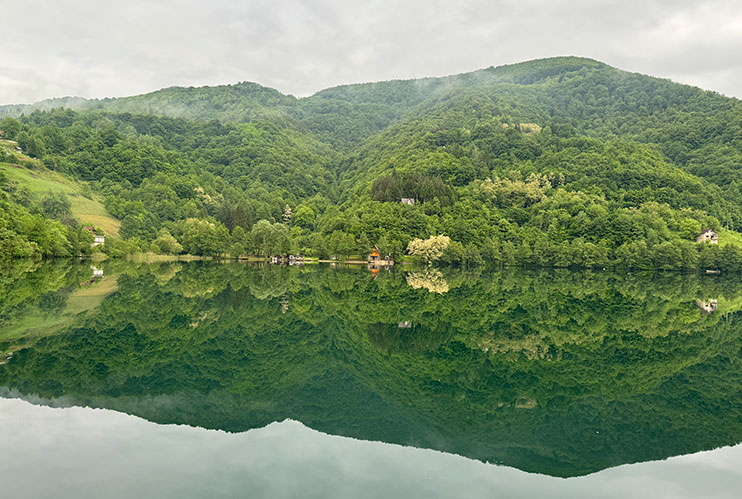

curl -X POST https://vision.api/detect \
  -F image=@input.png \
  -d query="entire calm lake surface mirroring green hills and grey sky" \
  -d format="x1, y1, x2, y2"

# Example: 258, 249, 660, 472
0, 261, 742, 498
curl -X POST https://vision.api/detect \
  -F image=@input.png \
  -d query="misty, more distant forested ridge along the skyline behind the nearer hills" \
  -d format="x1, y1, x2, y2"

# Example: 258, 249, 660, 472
7, 57, 742, 188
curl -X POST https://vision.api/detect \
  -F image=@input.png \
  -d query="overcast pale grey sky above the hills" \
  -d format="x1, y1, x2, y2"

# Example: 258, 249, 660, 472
0, 0, 742, 104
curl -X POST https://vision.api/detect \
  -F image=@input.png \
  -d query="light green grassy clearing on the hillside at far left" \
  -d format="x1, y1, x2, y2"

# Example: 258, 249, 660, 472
0, 141, 121, 237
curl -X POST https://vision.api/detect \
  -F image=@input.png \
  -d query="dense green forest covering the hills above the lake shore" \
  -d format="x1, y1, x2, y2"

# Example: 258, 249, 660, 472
0, 57, 742, 271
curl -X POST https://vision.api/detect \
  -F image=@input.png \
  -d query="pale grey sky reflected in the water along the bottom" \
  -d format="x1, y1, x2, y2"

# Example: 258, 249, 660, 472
0, 399, 742, 499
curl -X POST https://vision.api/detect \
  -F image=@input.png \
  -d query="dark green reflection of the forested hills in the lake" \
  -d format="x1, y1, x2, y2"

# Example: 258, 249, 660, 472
0, 262, 742, 476
